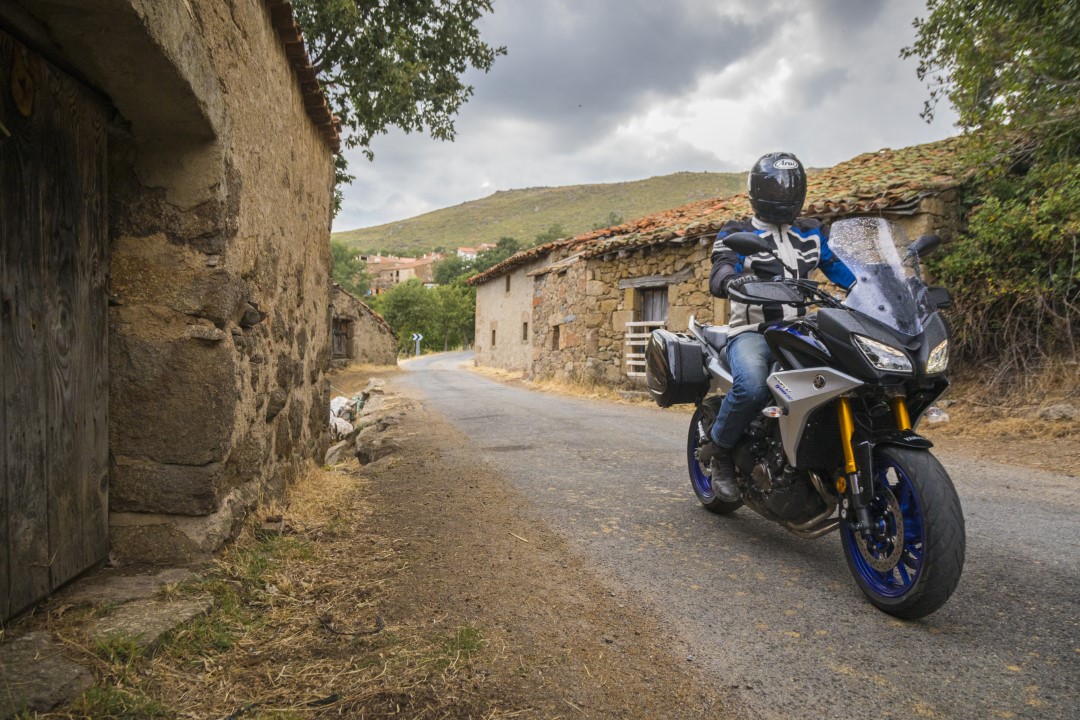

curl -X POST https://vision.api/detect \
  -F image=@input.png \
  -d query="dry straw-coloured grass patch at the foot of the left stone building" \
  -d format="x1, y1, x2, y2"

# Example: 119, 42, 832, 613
39, 466, 496, 719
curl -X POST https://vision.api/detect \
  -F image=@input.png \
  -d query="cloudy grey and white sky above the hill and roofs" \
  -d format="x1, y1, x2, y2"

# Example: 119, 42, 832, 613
334, 0, 956, 231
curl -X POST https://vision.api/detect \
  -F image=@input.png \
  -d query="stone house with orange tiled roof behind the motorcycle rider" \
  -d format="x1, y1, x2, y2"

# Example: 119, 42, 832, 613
469, 139, 966, 386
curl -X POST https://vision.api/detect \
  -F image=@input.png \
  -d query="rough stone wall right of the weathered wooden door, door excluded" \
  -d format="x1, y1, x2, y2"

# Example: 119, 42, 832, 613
4, 0, 333, 561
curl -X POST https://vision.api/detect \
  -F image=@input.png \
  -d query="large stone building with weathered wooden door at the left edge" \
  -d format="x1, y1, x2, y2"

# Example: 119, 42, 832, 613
0, 0, 338, 617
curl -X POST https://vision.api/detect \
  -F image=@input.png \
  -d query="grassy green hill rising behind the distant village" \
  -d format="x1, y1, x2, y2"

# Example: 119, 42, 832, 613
332, 173, 746, 255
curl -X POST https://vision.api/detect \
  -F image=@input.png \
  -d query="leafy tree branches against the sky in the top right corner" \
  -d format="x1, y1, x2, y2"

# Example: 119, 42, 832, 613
901, 0, 1080, 159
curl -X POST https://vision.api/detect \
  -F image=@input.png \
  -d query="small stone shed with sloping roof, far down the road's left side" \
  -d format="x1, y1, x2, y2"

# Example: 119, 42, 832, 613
330, 283, 397, 367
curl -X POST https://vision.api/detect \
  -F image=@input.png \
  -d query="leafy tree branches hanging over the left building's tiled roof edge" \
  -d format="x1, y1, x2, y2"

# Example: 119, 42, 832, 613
293, 0, 507, 208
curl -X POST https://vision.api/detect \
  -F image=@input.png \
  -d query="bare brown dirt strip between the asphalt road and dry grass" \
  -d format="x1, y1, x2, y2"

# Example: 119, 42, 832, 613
308, 373, 733, 718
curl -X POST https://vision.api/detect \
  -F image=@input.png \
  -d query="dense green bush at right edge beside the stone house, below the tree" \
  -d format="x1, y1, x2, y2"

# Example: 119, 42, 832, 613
929, 162, 1080, 379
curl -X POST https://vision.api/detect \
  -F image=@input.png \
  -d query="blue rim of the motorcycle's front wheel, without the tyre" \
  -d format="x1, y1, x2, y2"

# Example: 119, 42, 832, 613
843, 459, 926, 598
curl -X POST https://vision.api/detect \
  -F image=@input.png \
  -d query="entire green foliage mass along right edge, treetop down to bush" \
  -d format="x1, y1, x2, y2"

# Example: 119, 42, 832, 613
901, 0, 1080, 377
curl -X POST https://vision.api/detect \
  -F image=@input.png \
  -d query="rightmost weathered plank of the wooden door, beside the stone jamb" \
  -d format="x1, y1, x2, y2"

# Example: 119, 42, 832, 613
34, 38, 107, 588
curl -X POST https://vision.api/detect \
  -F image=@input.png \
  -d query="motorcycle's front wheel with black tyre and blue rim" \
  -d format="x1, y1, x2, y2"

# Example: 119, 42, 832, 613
840, 447, 966, 620
